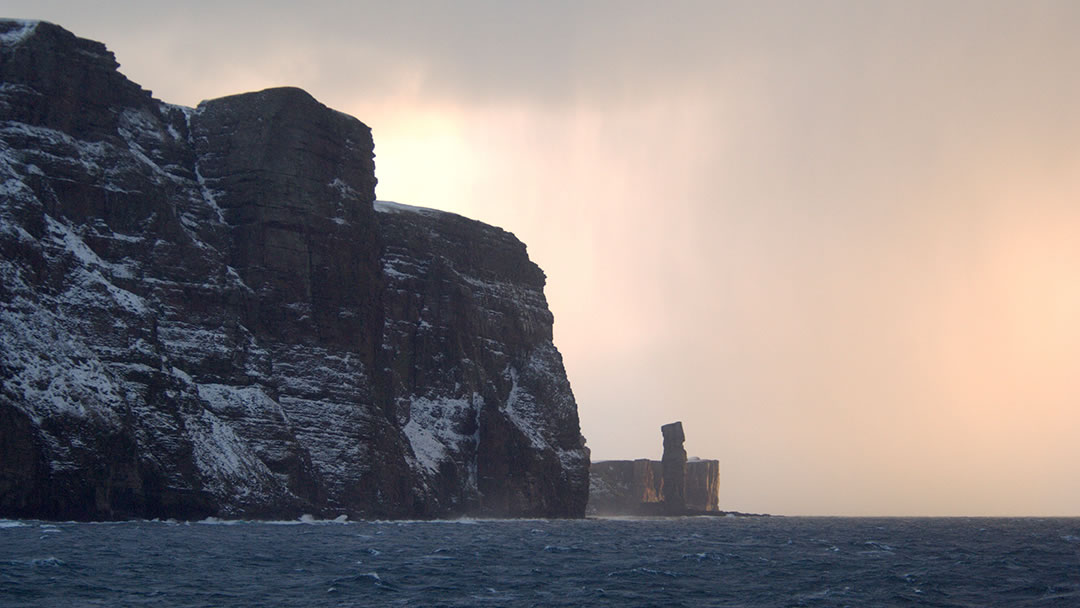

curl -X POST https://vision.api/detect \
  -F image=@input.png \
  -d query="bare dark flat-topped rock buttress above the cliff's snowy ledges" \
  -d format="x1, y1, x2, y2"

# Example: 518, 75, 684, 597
191, 87, 382, 352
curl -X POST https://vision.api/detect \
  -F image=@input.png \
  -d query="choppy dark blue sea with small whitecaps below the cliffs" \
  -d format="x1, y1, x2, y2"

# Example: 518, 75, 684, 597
0, 517, 1080, 607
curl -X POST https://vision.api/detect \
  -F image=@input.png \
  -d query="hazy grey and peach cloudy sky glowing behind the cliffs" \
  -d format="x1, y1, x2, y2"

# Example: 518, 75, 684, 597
4, 0, 1080, 516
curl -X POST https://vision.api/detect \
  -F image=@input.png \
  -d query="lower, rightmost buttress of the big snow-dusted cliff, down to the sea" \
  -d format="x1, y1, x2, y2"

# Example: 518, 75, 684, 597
375, 201, 589, 516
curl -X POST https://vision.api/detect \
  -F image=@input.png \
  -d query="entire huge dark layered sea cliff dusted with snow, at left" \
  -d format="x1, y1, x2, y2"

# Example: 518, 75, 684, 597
0, 21, 589, 519
